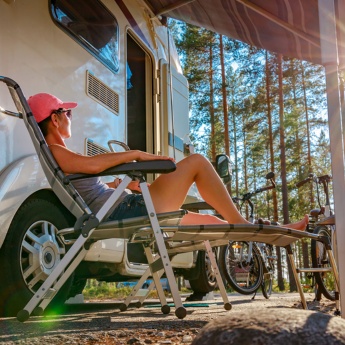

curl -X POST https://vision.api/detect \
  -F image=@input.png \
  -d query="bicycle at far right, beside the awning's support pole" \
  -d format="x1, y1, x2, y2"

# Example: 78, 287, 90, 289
296, 173, 339, 301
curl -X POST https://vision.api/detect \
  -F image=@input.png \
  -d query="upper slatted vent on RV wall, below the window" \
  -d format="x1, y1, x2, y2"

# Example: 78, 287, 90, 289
86, 71, 119, 115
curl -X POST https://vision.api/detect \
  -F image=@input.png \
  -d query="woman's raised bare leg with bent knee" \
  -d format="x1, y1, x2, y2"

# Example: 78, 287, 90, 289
150, 154, 249, 224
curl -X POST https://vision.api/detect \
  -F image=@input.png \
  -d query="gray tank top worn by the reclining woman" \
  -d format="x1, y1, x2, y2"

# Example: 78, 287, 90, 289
73, 177, 129, 214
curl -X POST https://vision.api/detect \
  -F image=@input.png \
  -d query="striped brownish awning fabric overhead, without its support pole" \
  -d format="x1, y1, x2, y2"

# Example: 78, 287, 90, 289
146, 0, 345, 67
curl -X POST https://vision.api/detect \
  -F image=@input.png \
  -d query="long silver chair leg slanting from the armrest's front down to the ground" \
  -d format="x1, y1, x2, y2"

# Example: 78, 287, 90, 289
140, 181, 187, 319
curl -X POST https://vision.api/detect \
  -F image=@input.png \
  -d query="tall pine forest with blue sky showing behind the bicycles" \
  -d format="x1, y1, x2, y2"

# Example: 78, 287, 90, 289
169, 20, 332, 291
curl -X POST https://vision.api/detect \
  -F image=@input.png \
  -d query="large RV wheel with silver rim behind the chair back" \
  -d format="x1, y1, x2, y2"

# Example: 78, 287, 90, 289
0, 199, 72, 316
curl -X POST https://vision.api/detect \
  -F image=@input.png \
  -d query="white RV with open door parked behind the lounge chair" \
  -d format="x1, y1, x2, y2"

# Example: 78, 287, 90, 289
0, 0, 214, 315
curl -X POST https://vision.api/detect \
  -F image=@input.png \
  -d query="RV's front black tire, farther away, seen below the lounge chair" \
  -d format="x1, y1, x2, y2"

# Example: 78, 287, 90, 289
189, 248, 217, 294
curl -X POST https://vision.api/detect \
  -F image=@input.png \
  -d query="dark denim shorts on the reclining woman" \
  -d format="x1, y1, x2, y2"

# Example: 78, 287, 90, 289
108, 194, 147, 220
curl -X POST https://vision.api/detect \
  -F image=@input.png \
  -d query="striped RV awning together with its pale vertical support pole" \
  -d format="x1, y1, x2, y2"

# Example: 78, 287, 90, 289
145, 0, 345, 318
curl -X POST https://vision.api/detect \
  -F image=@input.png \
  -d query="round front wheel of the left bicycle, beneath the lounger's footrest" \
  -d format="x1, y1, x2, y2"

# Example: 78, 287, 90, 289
219, 241, 263, 295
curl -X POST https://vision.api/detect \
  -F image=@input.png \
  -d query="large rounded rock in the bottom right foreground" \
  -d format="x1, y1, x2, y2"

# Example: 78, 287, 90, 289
192, 308, 345, 345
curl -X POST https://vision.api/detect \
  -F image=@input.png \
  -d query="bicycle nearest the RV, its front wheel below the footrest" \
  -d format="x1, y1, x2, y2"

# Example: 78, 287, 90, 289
219, 172, 275, 299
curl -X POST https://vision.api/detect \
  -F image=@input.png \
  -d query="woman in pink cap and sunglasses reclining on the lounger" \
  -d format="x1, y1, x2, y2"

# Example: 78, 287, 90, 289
28, 93, 308, 230
